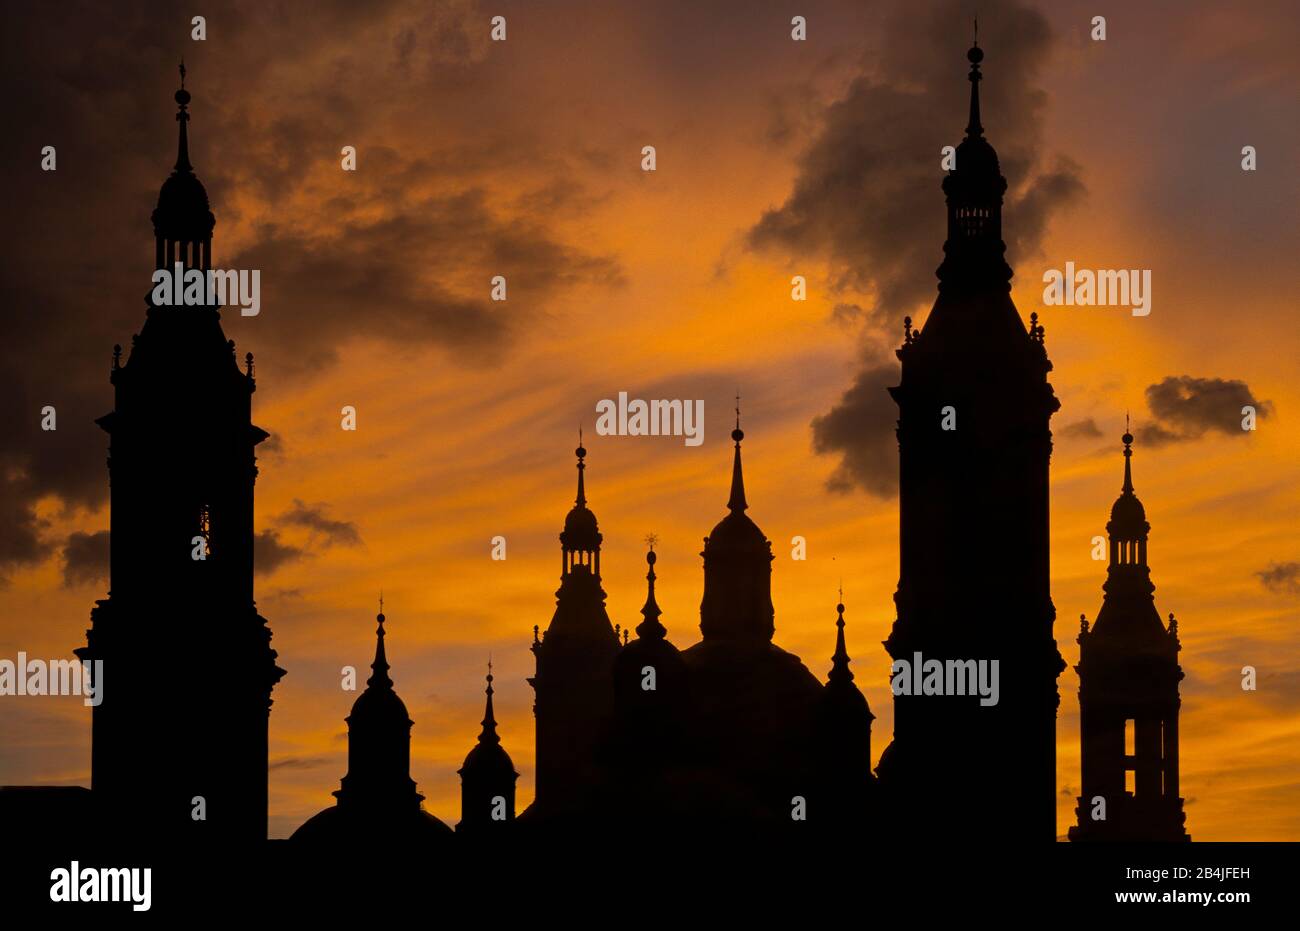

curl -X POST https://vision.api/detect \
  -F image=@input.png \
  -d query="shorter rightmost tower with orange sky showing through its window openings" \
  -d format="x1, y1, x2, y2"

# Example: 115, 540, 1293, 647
1070, 432, 1191, 841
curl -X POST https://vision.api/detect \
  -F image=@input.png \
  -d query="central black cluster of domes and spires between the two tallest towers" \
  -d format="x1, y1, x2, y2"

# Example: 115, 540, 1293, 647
520, 415, 874, 831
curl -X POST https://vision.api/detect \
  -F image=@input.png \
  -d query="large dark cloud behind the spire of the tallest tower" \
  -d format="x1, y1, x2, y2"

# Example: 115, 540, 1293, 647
748, 0, 1083, 495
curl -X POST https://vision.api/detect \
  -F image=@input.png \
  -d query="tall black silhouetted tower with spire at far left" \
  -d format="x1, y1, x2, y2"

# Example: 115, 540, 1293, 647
77, 70, 283, 844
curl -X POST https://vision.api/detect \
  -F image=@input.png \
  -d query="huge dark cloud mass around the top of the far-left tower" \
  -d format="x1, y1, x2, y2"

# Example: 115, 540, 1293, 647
0, 0, 621, 577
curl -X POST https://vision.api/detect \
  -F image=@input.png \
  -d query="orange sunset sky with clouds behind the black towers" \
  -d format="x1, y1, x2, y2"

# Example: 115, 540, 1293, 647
0, 0, 1300, 840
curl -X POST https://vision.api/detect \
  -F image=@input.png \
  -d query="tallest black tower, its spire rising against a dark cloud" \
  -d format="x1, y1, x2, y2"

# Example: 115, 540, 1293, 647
878, 46, 1065, 843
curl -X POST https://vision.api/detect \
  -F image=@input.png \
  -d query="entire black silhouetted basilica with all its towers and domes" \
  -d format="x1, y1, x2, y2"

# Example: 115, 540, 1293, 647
0, 38, 1187, 850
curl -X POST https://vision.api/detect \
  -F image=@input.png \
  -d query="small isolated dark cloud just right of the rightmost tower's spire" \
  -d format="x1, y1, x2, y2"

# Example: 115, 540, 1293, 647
1138, 374, 1273, 446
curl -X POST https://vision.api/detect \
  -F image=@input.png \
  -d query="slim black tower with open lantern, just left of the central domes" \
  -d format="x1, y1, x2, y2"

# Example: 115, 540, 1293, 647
528, 434, 619, 818
